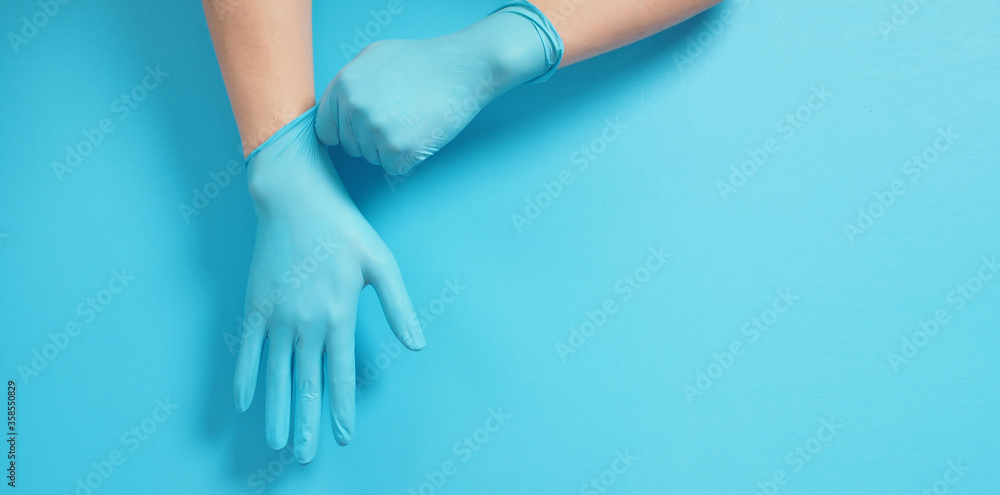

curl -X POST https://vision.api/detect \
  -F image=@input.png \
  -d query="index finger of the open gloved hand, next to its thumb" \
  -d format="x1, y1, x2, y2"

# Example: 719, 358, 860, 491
326, 310, 357, 445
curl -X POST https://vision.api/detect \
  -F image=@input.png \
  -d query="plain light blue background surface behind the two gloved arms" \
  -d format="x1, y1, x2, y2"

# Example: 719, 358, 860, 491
0, 0, 1000, 495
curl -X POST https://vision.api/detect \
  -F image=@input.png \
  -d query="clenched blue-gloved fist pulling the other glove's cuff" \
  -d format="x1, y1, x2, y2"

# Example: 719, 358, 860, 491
316, 2, 563, 175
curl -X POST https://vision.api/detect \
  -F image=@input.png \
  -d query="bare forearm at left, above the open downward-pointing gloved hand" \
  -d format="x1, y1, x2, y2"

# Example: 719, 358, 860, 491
202, 0, 316, 156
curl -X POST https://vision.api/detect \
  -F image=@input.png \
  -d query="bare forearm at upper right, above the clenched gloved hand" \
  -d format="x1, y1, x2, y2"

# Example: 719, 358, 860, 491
532, 0, 720, 67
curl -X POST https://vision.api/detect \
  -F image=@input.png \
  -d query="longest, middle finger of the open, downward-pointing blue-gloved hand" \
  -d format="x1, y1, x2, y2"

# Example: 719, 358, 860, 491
294, 329, 324, 464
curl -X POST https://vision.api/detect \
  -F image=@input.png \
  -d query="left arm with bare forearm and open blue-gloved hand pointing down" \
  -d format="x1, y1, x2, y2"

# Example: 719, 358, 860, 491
204, 0, 424, 463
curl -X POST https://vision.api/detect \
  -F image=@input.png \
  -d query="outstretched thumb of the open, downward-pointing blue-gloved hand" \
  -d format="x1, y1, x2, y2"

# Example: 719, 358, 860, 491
369, 255, 427, 351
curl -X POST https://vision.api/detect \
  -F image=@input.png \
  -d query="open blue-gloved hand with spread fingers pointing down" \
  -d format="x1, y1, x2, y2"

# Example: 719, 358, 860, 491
234, 107, 425, 464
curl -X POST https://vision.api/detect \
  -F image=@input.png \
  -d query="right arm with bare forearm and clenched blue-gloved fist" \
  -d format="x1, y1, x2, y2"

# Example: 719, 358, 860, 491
316, 0, 718, 175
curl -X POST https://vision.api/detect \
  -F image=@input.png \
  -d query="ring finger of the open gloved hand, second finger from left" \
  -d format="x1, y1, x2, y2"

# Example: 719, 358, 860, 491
264, 327, 293, 450
